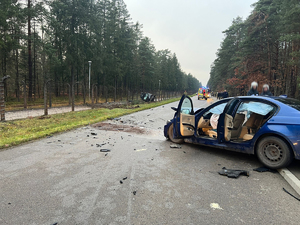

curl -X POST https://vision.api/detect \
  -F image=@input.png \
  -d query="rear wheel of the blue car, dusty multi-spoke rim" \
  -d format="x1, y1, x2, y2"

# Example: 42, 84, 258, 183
256, 137, 293, 169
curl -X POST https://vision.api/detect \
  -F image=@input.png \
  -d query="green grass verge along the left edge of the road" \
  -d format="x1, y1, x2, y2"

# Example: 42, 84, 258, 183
0, 98, 180, 149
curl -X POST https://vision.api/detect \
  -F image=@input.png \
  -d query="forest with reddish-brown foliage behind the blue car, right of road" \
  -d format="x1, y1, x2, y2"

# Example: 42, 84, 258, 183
208, 0, 300, 99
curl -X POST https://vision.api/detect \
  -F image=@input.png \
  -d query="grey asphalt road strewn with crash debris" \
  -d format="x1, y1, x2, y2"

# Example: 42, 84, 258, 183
0, 98, 299, 225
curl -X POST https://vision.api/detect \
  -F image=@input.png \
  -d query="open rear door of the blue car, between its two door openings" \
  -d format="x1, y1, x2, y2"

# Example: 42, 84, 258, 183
217, 98, 240, 143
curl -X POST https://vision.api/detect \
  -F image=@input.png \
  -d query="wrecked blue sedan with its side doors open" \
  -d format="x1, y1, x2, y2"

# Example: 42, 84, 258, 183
164, 95, 300, 169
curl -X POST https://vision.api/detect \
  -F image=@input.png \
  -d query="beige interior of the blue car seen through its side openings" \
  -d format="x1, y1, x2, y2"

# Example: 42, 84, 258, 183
197, 101, 276, 142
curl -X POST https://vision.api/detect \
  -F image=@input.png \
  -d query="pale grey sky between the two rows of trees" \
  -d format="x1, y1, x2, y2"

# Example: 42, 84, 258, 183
124, 0, 257, 85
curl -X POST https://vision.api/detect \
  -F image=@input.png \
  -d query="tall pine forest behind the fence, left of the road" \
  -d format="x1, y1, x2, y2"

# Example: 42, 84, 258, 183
0, 0, 201, 101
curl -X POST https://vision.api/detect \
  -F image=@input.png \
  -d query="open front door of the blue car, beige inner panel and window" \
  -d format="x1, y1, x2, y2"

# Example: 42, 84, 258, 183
173, 95, 195, 139
